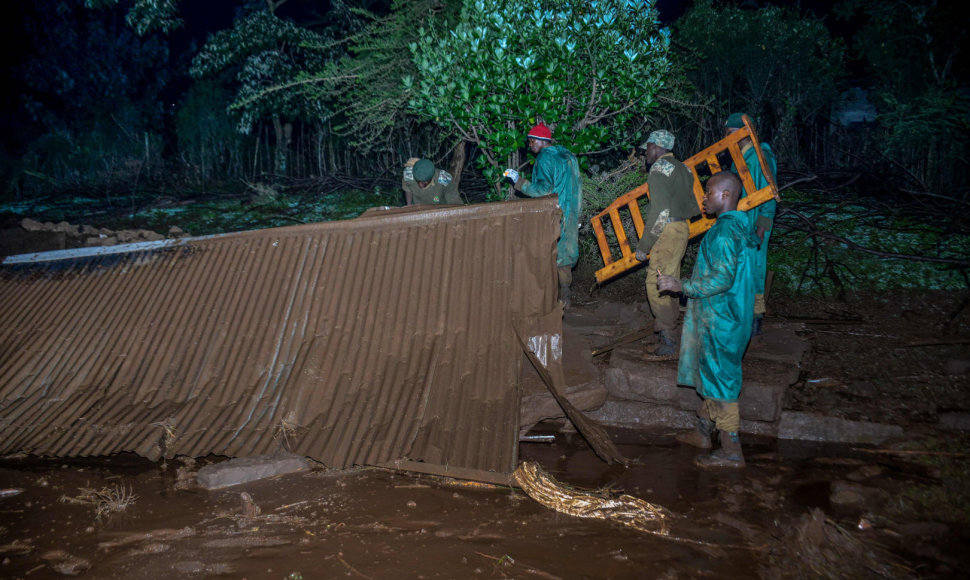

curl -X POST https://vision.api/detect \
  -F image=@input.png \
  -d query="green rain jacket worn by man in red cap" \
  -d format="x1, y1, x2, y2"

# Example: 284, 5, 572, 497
515, 145, 583, 267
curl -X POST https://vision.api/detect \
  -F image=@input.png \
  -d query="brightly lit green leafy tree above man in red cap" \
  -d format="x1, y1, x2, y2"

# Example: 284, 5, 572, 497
404, 0, 670, 183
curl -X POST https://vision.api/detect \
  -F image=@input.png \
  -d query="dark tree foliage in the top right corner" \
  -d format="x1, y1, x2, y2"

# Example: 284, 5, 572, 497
838, 0, 970, 191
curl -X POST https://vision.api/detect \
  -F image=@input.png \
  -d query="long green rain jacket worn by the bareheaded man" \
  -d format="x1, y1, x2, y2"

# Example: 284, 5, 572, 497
677, 211, 758, 402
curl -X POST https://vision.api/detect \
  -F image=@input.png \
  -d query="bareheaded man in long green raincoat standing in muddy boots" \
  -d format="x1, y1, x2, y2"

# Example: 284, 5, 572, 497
657, 171, 758, 468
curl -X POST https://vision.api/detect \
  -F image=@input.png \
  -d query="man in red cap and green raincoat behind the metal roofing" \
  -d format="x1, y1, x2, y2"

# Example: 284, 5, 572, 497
503, 123, 583, 307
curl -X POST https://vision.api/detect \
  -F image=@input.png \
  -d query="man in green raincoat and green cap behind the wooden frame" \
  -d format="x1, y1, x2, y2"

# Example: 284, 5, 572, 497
724, 113, 778, 336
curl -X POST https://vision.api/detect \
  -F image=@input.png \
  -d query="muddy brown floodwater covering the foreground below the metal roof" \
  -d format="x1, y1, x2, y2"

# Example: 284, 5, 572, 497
0, 425, 966, 579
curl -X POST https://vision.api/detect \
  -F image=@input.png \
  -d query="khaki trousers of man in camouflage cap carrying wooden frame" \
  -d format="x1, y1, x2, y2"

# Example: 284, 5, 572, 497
647, 221, 690, 332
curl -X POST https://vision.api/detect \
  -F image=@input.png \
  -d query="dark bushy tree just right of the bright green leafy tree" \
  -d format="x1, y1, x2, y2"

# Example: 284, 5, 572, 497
676, 0, 845, 163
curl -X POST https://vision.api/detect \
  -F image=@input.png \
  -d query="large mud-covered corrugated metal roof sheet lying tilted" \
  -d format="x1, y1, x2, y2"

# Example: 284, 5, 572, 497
0, 199, 559, 480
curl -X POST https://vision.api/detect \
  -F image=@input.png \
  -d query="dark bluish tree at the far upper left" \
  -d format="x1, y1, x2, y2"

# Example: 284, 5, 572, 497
17, 0, 169, 187
